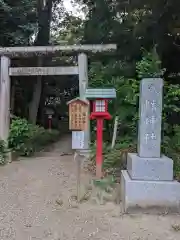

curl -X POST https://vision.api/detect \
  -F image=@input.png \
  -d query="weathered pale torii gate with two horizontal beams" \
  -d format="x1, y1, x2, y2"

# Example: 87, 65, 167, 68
0, 44, 117, 150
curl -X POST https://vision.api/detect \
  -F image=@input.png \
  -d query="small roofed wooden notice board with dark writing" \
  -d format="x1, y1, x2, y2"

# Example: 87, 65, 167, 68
68, 99, 89, 131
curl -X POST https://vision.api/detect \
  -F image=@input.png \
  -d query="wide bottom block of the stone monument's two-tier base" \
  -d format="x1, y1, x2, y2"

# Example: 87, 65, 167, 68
121, 171, 180, 212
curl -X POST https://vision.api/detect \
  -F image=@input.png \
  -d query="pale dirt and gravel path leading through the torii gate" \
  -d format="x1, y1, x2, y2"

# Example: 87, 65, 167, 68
0, 137, 180, 240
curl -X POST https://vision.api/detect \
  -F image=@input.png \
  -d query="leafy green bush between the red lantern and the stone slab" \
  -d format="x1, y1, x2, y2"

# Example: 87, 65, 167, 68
90, 61, 139, 140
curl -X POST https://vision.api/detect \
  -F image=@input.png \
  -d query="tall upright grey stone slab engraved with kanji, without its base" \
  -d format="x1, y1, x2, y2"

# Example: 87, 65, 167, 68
138, 78, 163, 158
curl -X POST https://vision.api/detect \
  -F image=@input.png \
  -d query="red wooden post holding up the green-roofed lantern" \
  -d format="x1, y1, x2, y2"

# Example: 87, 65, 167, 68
96, 118, 103, 178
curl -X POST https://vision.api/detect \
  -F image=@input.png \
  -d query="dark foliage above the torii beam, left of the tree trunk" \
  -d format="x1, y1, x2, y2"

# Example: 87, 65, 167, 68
0, 0, 37, 46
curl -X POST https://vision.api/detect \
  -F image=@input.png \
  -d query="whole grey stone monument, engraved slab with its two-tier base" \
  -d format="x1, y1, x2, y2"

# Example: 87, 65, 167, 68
121, 78, 180, 212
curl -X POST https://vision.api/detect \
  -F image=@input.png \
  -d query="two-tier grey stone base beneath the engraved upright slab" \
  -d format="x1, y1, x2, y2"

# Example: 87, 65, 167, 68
121, 158, 180, 213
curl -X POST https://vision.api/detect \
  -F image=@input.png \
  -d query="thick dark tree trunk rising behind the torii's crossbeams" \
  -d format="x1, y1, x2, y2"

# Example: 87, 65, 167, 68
29, 0, 52, 124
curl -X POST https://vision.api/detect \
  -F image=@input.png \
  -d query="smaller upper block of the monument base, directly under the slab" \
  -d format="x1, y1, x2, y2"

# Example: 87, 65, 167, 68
127, 153, 173, 181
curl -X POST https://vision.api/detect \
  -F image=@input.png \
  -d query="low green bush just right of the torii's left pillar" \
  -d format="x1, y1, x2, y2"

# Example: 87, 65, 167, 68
9, 118, 59, 156
